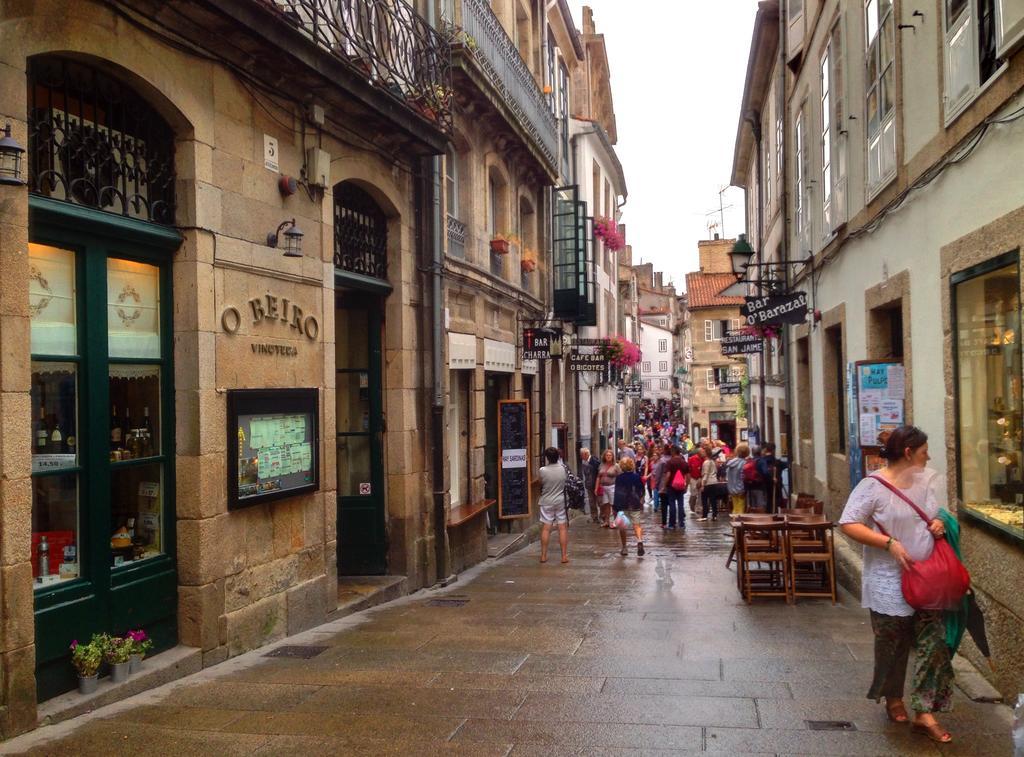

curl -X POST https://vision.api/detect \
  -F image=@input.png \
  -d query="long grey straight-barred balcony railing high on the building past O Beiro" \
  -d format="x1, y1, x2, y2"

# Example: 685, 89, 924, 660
450, 0, 558, 168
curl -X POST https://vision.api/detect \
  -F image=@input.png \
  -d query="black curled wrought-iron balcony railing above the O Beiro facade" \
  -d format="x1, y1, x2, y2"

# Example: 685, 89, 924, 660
268, 0, 452, 132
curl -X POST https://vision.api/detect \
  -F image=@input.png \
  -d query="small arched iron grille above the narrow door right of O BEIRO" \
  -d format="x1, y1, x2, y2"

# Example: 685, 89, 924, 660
334, 181, 387, 280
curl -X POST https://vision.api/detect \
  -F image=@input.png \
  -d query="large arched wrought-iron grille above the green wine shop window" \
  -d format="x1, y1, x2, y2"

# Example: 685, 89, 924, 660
29, 56, 174, 225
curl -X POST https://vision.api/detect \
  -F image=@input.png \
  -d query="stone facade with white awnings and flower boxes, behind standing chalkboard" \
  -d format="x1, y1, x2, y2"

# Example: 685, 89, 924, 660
443, 0, 583, 572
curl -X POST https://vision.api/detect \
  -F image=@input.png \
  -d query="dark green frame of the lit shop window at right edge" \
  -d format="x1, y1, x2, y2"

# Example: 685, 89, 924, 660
949, 249, 1024, 548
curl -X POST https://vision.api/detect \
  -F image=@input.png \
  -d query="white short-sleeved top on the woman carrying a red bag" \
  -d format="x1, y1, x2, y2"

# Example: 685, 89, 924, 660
840, 469, 942, 617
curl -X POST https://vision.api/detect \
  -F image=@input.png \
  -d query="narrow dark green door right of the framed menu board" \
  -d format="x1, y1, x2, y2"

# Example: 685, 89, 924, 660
336, 294, 387, 576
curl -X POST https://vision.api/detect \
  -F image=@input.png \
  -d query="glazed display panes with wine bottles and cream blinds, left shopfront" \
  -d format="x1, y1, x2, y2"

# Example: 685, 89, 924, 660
29, 240, 173, 602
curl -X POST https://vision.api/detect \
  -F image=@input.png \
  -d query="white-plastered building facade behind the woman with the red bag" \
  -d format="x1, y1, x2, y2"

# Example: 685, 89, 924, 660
733, 0, 1024, 697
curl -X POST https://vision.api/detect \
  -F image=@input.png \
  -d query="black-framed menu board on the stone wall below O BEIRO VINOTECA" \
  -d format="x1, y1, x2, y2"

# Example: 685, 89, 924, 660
227, 389, 319, 509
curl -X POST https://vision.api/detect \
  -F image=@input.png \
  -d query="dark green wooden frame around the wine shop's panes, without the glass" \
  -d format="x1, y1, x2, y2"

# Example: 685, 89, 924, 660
29, 195, 182, 701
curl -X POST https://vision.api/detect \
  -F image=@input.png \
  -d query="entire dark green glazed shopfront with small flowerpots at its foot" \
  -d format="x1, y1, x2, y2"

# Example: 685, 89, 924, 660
29, 197, 180, 701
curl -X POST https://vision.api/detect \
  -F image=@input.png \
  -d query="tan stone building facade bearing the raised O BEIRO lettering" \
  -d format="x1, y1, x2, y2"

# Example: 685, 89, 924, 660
0, 0, 451, 735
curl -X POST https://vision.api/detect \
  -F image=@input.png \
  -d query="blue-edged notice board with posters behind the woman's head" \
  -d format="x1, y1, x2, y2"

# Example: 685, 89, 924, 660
851, 361, 906, 475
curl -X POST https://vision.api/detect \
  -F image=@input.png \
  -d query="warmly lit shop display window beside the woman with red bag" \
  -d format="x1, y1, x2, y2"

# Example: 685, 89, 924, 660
952, 254, 1024, 539
